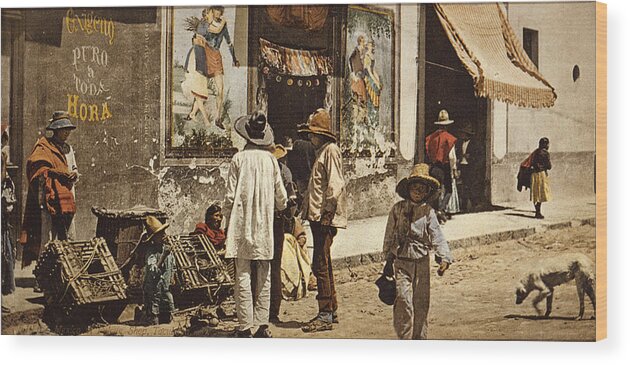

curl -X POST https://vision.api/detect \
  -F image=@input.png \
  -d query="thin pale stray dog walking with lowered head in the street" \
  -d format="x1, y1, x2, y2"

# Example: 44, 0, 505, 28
516, 254, 595, 320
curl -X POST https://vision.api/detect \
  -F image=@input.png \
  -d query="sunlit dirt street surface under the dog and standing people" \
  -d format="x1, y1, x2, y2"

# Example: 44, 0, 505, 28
2, 226, 595, 341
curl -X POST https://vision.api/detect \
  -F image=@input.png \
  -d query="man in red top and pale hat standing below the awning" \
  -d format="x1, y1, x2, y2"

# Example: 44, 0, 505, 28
425, 109, 457, 221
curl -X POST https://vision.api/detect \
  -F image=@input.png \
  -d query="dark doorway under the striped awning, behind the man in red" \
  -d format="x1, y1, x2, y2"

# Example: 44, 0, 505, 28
424, 6, 489, 208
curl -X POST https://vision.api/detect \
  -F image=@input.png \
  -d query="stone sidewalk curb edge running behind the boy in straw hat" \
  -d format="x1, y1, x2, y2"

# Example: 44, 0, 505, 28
332, 217, 595, 270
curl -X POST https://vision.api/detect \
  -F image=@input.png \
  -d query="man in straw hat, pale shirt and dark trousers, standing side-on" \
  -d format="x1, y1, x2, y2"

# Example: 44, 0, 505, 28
302, 109, 348, 332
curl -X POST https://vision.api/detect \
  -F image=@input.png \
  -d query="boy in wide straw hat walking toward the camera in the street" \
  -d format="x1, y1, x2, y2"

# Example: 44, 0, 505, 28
383, 164, 453, 340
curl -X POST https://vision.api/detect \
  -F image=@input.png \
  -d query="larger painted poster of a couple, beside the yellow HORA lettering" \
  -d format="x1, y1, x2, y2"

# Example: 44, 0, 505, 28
166, 6, 247, 157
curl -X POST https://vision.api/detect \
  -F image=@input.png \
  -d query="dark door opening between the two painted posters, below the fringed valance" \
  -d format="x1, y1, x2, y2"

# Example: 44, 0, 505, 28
266, 75, 326, 143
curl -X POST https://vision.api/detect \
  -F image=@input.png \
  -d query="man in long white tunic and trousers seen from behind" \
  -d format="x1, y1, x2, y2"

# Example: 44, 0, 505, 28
223, 112, 287, 337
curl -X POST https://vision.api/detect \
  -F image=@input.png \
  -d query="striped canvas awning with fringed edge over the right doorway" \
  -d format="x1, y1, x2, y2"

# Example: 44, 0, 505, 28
435, 3, 557, 108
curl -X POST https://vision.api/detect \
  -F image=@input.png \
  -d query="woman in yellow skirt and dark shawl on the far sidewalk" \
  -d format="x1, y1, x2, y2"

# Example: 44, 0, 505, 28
530, 137, 551, 219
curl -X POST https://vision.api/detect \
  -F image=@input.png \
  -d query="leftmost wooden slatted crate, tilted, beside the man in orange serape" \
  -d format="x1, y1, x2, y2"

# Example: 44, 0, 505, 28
34, 237, 127, 306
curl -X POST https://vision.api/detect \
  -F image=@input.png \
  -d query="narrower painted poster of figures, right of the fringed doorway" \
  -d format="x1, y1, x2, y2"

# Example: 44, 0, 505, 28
341, 6, 394, 156
